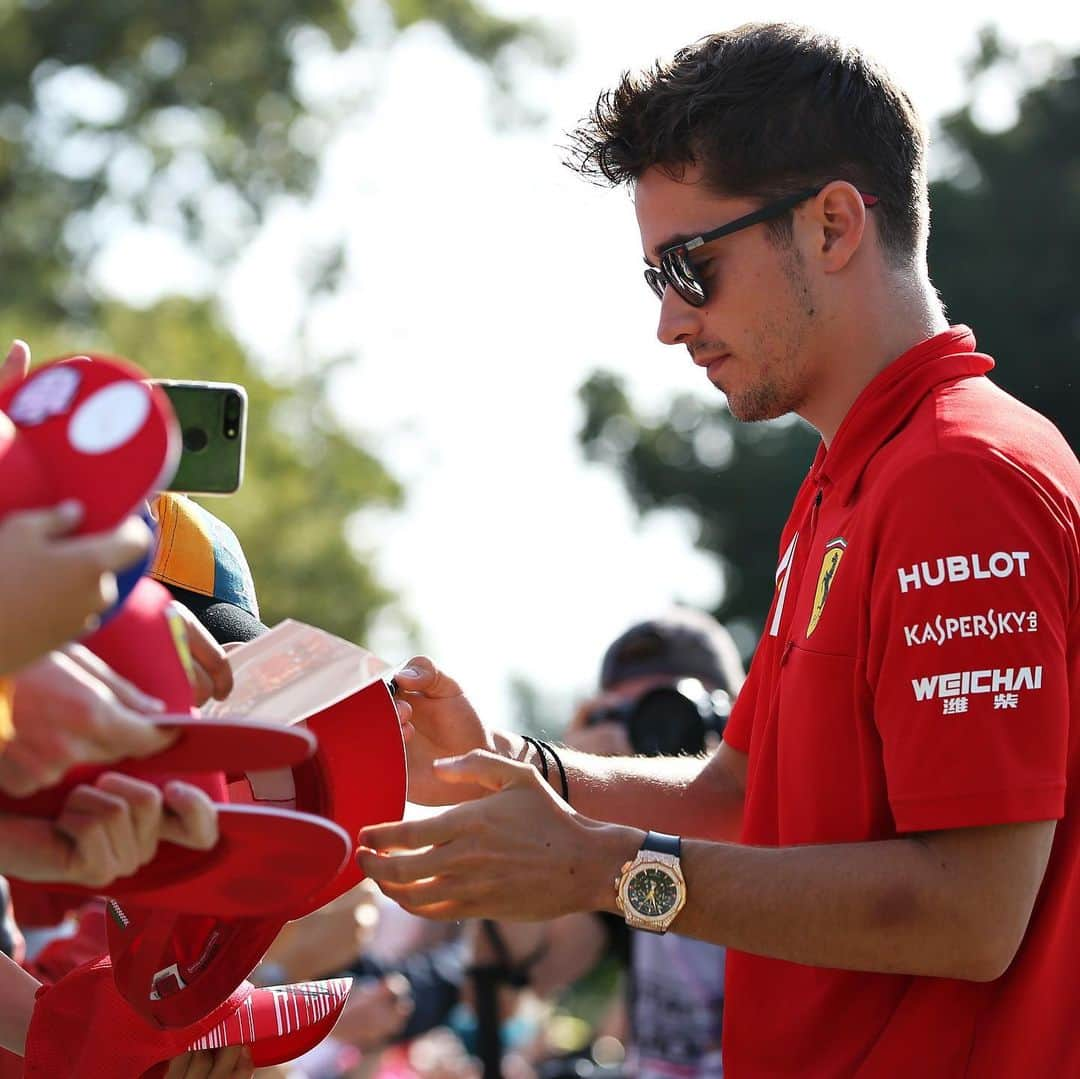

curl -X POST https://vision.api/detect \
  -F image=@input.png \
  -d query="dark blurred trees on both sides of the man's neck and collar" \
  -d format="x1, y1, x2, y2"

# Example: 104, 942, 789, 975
580, 31, 1080, 637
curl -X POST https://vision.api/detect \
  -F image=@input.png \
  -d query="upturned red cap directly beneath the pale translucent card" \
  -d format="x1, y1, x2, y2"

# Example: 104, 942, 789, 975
229, 679, 406, 918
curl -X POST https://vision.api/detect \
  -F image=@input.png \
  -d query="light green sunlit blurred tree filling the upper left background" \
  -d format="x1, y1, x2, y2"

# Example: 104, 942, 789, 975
0, 0, 559, 639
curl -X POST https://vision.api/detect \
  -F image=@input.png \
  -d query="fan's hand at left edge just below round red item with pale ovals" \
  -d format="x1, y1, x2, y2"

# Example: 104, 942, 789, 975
0, 502, 151, 673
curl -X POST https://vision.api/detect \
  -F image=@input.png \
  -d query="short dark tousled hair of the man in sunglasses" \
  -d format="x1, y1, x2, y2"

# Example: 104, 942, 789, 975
566, 23, 929, 264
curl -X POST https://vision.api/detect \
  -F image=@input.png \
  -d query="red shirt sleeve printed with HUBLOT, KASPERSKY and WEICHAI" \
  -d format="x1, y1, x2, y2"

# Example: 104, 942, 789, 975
866, 453, 1077, 832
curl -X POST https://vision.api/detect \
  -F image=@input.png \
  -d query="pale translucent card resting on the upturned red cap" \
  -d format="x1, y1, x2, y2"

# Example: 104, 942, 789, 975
201, 619, 391, 726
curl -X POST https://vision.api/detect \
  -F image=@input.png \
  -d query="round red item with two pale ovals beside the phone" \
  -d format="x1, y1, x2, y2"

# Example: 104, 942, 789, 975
0, 355, 180, 534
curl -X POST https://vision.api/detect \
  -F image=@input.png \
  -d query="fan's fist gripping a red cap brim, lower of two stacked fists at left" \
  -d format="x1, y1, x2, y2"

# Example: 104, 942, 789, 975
0, 772, 218, 891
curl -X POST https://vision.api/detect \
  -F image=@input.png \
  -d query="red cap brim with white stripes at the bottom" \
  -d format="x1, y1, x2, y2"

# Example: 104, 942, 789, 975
188, 977, 352, 1068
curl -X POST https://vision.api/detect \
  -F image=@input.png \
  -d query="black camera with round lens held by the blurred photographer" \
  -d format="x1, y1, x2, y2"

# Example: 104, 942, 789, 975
585, 678, 731, 757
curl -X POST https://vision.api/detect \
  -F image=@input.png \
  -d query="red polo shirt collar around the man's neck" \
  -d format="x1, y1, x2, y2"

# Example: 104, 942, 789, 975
810, 325, 994, 502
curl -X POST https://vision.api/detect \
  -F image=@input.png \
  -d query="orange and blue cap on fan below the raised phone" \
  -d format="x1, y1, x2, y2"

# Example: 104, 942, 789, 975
148, 493, 267, 644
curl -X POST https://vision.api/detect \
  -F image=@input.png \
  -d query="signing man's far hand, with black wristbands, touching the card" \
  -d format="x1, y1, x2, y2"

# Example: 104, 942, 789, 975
394, 656, 503, 806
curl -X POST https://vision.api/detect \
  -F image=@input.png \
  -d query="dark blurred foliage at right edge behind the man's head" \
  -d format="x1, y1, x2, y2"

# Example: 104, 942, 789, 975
930, 47, 1080, 449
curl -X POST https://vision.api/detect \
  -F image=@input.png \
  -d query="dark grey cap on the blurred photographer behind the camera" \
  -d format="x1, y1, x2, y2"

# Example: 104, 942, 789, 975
600, 607, 743, 697
